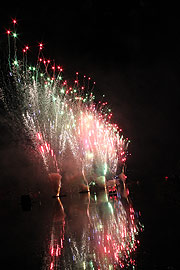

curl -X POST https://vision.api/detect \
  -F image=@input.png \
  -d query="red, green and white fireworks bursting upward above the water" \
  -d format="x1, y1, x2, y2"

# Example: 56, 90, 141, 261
1, 20, 129, 188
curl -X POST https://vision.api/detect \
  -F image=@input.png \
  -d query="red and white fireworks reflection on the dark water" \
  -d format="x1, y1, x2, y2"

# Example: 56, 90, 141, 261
43, 192, 141, 270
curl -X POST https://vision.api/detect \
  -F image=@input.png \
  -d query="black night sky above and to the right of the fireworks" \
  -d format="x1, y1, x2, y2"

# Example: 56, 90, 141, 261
0, 0, 180, 179
